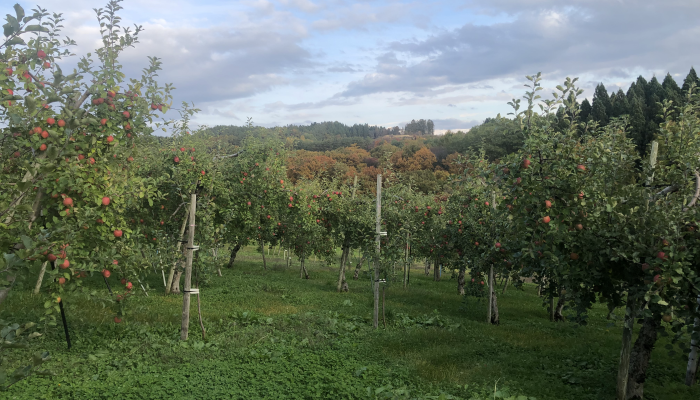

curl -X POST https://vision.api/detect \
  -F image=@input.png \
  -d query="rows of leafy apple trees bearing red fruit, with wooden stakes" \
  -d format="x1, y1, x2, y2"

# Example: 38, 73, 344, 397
0, 1, 700, 399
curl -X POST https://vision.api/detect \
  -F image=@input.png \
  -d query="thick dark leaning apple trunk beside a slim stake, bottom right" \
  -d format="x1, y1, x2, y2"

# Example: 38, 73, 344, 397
627, 317, 661, 400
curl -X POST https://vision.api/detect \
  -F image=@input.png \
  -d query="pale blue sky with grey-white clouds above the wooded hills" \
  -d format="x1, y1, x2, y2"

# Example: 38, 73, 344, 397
21, 0, 700, 130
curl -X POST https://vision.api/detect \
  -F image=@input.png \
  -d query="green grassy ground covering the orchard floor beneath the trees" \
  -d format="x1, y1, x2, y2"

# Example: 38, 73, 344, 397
0, 245, 700, 400
